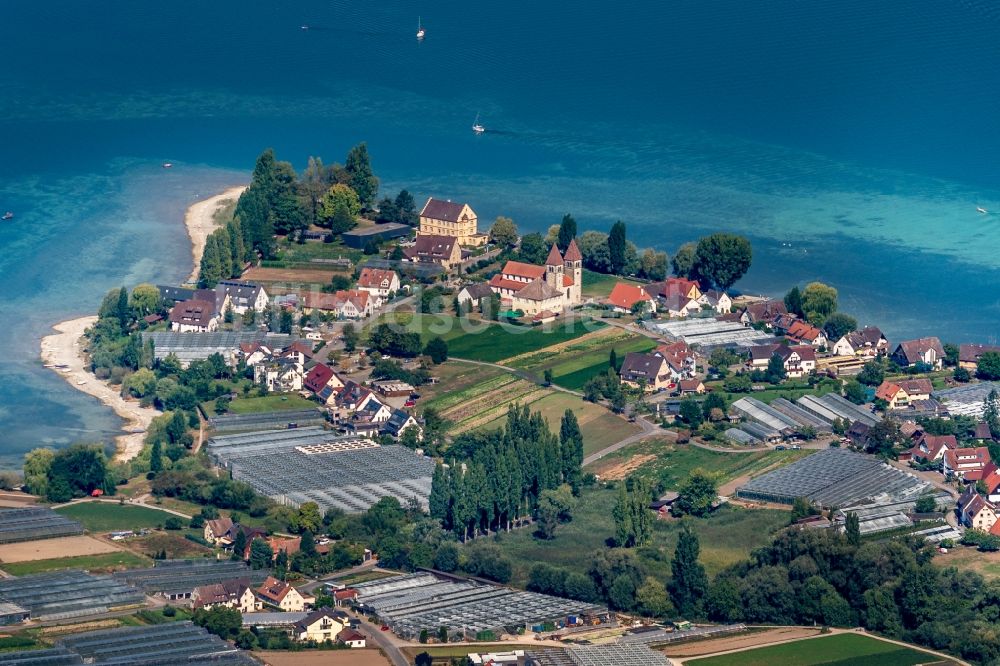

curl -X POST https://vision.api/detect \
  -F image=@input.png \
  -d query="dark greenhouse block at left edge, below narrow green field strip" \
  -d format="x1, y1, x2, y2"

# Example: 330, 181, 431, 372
0, 569, 146, 620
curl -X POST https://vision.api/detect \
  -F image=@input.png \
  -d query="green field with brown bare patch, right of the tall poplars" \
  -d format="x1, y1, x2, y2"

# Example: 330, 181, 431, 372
587, 439, 814, 490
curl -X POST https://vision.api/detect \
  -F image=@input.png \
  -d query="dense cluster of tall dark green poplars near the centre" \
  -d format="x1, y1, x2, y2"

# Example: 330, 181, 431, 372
430, 405, 583, 540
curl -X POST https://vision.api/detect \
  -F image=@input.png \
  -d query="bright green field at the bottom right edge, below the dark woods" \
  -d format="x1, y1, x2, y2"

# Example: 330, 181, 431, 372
685, 634, 955, 666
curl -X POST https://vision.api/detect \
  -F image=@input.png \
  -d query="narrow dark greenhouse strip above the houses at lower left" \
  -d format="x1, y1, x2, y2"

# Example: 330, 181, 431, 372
114, 559, 270, 595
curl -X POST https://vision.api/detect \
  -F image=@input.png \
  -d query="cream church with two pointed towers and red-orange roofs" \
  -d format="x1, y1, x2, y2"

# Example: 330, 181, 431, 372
489, 240, 583, 317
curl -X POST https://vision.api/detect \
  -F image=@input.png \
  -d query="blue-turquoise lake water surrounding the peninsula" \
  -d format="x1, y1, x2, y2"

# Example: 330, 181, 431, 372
0, 0, 1000, 461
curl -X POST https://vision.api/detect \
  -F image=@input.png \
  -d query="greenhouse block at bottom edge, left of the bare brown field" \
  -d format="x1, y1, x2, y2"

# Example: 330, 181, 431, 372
59, 622, 260, 666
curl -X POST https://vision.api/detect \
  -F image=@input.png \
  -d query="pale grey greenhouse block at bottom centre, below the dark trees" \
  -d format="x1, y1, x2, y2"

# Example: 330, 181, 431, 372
351, 573, 607, 637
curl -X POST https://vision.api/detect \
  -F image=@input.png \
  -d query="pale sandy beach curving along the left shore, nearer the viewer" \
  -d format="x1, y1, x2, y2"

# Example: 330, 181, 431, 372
42, 315, 161, 461
